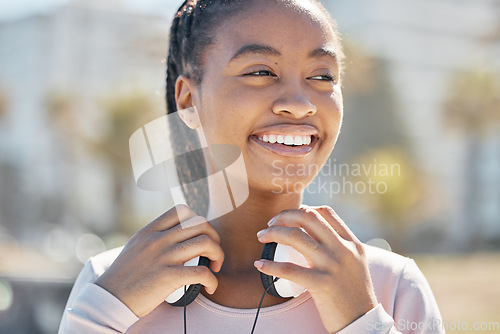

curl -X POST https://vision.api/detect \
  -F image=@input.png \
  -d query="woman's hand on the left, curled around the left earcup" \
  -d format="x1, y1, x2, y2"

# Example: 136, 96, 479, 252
96, 205, 224, 317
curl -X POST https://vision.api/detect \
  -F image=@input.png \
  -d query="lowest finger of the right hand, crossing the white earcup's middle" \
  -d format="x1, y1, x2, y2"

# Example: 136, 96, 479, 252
254, 260, 316, 290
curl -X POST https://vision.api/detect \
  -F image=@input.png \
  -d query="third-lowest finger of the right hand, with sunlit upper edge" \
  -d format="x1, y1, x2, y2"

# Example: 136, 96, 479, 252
270, 208, 340, 247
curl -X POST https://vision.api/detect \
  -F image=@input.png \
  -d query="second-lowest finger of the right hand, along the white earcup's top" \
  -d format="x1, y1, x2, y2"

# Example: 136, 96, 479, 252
258, 225, 332, 267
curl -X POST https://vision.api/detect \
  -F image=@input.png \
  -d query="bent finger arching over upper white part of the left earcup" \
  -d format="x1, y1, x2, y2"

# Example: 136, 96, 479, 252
168, 234, 224, 272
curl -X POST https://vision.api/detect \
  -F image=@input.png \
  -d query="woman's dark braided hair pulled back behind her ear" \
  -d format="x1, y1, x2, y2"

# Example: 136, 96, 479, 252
166, 0, 341, 216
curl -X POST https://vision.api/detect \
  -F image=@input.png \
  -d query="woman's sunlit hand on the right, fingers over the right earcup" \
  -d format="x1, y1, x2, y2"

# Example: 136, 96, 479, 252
256, 206, 378, 333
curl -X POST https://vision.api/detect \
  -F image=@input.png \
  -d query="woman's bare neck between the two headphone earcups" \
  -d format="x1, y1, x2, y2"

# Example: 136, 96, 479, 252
196, 146, 302, 308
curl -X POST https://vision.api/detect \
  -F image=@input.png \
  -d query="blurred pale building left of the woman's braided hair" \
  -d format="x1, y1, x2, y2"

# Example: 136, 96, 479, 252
0, 1, 174, 241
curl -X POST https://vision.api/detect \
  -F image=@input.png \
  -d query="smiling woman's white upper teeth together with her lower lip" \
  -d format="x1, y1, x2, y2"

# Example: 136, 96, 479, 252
250, 134, 318, 157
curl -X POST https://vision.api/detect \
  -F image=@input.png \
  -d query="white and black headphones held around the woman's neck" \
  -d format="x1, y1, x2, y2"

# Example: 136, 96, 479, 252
165, 242, 307, 306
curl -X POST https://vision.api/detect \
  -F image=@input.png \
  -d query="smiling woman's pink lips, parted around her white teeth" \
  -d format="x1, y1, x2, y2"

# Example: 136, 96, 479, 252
249, 124, 319, 157
